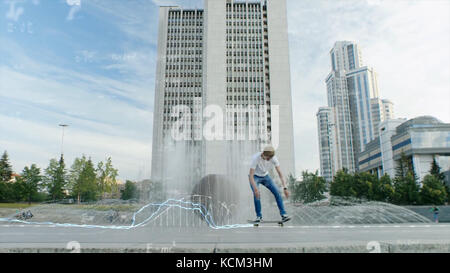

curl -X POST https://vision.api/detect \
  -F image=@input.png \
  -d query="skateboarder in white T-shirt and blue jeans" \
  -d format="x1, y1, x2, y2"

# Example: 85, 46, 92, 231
249, 146, 291, 223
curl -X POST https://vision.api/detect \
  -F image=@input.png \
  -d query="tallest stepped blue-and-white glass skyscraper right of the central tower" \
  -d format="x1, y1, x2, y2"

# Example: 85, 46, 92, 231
321, 41, 392, 172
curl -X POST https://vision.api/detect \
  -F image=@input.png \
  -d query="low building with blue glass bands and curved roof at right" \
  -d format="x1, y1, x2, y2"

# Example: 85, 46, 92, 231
359, 116, 450, 181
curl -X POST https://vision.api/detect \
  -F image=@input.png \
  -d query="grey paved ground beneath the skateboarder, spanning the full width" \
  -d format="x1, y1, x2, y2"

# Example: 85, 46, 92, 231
0, 224, 450, 252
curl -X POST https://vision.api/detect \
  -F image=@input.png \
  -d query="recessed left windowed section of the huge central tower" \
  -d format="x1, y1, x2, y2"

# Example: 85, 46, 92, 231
152, 6, 204, 191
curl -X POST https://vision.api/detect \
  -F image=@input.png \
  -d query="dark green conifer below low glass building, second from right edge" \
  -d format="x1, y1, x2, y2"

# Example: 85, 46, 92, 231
393, 173, 420, 205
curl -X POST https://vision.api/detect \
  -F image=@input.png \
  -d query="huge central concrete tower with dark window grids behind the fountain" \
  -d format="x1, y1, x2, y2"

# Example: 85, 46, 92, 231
152, 0, 295, 191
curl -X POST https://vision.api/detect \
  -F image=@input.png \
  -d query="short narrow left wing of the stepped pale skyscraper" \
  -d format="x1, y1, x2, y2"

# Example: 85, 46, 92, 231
316, 107, 337, 182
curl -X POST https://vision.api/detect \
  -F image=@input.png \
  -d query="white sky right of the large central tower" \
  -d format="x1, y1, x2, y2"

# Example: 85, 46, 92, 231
288, 0, 450, 175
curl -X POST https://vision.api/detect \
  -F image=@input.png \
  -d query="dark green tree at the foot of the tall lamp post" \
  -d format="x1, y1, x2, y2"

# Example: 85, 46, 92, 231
45, 155, 67, 200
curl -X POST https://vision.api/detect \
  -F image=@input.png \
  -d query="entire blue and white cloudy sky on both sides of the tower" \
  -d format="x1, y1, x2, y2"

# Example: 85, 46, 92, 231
0, 0, 450, 180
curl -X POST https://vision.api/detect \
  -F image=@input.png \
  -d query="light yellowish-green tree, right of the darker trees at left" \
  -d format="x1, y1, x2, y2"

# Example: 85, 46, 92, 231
97, 157, 119, 199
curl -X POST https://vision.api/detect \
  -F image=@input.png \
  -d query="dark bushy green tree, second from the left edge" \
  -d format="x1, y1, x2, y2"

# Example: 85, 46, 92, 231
14, 164, 42, 204
